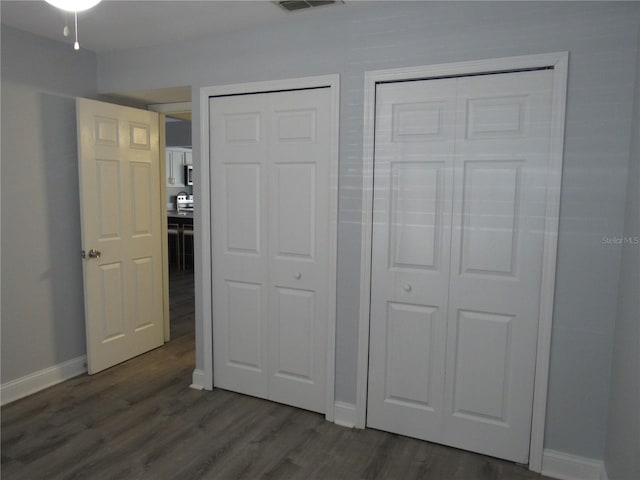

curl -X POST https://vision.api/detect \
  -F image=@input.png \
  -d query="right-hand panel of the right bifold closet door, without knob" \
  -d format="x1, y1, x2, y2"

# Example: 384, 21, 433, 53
443, 70, 552, 463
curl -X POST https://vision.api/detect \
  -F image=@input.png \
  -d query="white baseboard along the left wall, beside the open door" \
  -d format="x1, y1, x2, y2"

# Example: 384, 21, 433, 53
0, 355, 87, 405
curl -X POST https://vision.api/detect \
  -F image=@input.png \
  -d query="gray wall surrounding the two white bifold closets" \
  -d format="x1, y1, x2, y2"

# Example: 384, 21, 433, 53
98, 1, 640, 458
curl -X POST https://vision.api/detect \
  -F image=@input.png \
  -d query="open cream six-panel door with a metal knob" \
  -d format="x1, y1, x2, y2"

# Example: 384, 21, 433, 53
76, 98, 164, 374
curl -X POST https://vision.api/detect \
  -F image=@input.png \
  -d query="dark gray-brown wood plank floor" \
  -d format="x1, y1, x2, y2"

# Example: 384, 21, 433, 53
1, 271, 556, 480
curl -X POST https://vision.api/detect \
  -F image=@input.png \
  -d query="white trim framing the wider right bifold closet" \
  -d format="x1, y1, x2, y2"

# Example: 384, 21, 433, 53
356, 52, 569, 472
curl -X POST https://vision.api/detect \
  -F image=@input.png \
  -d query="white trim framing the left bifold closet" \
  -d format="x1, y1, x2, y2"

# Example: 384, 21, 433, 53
199, 74, 340, 421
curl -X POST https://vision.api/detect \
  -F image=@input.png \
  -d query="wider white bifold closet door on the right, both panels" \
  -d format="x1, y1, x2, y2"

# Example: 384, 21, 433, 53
367, 70, 552, 463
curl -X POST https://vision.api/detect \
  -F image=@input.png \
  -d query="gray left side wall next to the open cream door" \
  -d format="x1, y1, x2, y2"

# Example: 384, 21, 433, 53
1, 25, 97, 383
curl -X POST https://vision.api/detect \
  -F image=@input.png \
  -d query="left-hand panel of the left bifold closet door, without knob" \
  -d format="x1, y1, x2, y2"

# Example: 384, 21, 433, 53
210, 95, 270, 398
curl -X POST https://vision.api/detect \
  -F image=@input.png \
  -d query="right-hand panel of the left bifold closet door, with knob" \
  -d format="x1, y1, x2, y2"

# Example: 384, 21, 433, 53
269, 88, 332, 412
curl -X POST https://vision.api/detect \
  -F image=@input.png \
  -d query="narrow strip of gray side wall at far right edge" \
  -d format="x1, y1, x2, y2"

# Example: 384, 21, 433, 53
605, 29, 640, 480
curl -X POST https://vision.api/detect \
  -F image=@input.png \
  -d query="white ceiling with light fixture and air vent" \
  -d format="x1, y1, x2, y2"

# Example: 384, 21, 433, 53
0, 0, 365, 53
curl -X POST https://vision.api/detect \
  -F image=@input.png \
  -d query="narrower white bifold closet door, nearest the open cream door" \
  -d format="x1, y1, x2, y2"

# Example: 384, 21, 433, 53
210, 88, 333, 412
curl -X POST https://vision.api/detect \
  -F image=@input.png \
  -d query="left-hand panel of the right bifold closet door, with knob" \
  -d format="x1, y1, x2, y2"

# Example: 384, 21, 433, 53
367, 80, 455, 441
